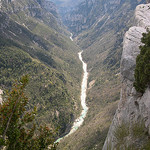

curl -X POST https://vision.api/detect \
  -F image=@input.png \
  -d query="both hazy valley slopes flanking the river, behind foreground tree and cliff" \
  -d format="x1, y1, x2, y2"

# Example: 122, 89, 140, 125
0, 0, 149, 150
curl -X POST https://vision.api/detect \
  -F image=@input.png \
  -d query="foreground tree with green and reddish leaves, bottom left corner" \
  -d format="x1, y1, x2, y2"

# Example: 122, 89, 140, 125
0, 76, 56, 150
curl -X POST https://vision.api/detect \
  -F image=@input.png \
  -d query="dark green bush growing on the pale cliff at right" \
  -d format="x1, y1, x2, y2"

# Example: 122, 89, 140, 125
134, 32, 150, 93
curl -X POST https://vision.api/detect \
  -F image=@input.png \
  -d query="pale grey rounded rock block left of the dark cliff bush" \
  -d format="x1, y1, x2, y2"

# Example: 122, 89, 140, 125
121, 27, 146, 81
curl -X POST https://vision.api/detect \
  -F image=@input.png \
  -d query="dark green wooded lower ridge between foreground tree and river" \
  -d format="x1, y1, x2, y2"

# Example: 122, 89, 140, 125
0, 44, 73, 135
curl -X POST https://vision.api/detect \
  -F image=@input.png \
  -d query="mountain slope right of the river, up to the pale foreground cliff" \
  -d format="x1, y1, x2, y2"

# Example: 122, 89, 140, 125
56, 0, 145, 150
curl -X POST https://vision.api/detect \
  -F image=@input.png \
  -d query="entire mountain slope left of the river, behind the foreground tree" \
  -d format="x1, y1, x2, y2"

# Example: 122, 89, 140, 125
0, 0, 82, 134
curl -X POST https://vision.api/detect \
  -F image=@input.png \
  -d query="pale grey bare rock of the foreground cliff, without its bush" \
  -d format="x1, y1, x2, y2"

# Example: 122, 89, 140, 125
103, 4, 150, 150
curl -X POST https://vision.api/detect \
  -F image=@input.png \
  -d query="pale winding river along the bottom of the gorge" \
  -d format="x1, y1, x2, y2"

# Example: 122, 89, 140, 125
55, 34, 88, 143
